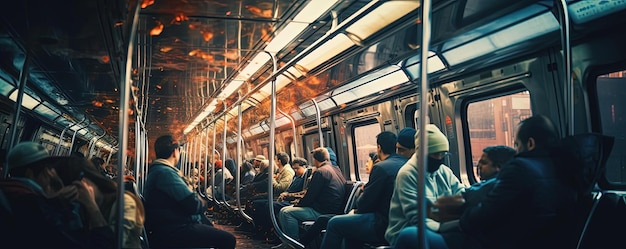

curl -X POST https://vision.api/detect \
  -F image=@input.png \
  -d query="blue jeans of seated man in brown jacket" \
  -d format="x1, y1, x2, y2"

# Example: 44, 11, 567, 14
278, 205, 322, 240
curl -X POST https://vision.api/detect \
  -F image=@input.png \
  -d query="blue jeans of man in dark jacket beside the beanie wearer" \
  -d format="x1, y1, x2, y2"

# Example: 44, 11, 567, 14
320, 213, 386, 249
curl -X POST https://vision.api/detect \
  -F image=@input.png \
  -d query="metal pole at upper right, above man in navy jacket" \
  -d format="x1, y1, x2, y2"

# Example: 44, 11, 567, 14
554, 0, 574, 135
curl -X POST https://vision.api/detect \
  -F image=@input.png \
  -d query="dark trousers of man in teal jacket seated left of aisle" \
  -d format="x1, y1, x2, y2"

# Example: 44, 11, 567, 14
148, 224, 236, 248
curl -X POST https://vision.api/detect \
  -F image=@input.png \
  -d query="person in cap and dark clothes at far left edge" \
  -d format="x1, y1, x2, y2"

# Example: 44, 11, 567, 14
0, 142, 109, 248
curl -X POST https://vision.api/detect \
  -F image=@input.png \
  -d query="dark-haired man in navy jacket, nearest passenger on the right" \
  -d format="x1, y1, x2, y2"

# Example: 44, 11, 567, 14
443, 115, 576, 248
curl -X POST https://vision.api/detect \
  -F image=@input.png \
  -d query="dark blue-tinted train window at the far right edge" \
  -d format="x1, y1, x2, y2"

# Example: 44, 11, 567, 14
596, 71, 626, 184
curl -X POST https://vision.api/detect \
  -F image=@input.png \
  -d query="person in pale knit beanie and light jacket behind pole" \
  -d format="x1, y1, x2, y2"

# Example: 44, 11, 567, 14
385, 124, 465, 248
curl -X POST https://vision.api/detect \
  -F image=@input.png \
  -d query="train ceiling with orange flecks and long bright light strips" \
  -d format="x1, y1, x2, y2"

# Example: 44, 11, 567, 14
0, 0, 610, 153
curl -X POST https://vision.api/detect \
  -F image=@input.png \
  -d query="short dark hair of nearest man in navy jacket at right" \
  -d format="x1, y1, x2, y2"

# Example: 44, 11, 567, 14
517, 115, 560, 150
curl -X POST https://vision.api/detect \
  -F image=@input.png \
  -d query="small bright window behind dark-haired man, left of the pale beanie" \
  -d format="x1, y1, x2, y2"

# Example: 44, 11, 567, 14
352, 122, 382, 182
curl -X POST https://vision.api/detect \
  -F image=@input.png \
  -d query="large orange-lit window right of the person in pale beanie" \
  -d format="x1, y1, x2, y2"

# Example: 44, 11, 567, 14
466, 91, 532, 179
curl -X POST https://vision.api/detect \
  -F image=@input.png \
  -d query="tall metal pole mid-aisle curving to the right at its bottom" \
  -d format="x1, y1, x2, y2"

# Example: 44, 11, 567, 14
264, 51, 302, 249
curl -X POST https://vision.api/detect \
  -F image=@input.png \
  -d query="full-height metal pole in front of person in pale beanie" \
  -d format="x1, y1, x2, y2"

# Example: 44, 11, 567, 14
417, 0, 431, 249
